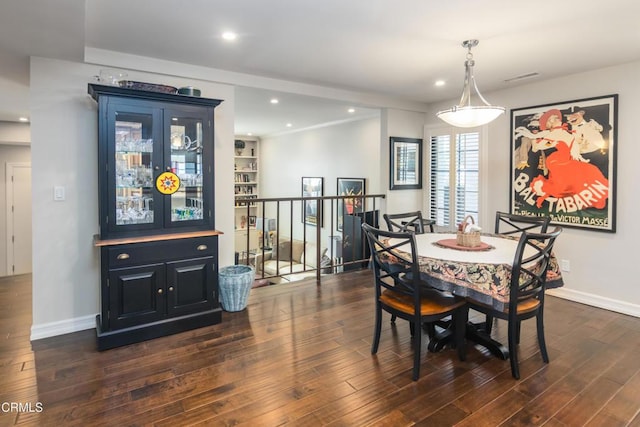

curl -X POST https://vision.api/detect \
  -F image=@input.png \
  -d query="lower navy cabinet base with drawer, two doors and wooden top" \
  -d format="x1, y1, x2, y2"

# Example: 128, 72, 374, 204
96, 231, 222, 350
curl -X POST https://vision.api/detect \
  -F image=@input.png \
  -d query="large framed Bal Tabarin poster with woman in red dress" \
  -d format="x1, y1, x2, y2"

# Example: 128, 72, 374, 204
510, 95, 618, 232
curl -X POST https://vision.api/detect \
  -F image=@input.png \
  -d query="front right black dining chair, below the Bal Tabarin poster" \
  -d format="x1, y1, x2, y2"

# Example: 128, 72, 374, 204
467, 227, 562, 379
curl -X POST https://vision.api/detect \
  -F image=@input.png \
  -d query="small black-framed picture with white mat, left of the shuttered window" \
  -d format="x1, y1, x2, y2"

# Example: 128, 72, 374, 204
389, 136, 422, 190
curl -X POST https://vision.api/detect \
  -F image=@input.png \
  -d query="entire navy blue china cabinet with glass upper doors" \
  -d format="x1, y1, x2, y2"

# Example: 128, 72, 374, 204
88, 84, 222, 350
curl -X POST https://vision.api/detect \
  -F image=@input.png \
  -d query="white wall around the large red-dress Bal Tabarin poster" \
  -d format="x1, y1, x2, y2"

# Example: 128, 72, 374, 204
427, 62, 640, 316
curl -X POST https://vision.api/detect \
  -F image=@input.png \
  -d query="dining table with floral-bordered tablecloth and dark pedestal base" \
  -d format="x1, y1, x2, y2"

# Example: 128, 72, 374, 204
389, 232, 563, 360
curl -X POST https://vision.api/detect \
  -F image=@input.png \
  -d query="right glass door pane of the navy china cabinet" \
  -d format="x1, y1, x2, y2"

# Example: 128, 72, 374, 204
165, 110, 213, 226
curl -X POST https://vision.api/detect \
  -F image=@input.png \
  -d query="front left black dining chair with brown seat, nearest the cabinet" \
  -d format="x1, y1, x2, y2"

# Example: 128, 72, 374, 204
362, 224, 467, 381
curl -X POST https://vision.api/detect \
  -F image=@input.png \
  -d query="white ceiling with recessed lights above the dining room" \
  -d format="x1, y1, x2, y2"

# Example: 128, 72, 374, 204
0, 0, 640, 133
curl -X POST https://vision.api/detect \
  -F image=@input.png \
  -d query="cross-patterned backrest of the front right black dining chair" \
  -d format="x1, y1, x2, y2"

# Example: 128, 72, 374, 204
509, 227, 562, 311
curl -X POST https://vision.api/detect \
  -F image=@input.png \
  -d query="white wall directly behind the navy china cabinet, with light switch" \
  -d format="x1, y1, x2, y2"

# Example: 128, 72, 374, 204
30, 58, 234, 339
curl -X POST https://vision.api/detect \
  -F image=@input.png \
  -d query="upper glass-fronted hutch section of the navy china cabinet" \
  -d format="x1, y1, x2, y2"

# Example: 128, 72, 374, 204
89, 84, 222, 240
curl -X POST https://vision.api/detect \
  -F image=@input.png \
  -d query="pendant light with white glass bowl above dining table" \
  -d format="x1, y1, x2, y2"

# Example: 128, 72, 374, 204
436, 40, 505, 128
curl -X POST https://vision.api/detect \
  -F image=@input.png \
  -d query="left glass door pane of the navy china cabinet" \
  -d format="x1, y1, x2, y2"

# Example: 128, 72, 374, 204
107, 104, 162, 236
